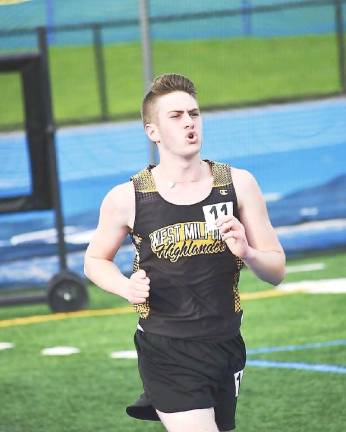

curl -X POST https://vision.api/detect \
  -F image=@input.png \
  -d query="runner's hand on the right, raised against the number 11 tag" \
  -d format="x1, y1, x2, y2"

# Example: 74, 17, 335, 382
216, 216, 250, 258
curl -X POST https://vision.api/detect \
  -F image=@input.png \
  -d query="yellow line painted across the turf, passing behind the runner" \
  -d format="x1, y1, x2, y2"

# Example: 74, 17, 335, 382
0, 289, 297, 328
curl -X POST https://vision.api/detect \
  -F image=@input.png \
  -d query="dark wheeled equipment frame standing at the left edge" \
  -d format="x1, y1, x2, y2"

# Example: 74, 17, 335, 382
0, 28, 88, 312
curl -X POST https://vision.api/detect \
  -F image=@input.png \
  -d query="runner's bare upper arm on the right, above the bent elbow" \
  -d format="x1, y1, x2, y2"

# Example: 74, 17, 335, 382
239, 173, 282, 251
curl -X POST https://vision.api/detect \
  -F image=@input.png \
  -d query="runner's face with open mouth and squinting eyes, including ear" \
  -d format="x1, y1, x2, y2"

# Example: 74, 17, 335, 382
147, 91, 202, 156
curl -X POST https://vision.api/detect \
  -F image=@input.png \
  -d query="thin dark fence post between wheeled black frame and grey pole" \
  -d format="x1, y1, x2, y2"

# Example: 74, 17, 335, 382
93, 24, 109, 120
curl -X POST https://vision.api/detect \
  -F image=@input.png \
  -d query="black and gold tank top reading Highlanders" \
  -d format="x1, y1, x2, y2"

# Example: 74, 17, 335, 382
131, 161, 243, 340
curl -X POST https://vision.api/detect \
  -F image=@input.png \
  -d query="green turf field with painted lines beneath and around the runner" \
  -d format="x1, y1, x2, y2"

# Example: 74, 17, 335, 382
0, 252, 346, 432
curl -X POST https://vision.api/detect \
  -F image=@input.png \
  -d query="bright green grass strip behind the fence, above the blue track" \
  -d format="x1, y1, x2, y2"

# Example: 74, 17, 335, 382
0, 34, 340, 126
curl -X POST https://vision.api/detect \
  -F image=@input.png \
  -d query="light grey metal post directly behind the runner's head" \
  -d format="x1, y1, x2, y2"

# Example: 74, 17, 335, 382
139, 0, 157, 164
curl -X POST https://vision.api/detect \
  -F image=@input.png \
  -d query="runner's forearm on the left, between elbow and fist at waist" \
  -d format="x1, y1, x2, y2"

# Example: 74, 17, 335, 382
84, 256, 129, 299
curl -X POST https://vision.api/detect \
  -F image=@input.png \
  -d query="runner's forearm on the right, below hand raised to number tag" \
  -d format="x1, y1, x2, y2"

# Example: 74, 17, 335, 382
243, 246, 286, 285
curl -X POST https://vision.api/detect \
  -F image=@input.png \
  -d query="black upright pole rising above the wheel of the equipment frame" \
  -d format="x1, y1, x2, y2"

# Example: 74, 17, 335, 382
37, 27, 67, 270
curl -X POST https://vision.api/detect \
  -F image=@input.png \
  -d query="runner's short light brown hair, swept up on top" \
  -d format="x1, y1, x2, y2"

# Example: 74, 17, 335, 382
141, 73, 197, 126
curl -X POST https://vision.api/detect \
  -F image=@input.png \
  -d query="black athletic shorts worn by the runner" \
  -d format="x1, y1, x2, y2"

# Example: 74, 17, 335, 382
126, 330, 246, 431
